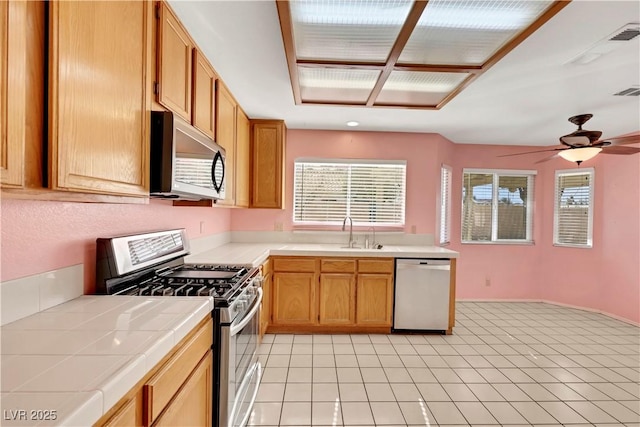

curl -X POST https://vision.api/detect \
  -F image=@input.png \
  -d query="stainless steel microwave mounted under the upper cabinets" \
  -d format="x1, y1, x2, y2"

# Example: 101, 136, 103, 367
150, 111, 225, 200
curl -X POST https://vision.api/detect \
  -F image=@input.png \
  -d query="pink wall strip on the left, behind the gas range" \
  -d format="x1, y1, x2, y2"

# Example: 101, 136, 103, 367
0, 199, 231, 293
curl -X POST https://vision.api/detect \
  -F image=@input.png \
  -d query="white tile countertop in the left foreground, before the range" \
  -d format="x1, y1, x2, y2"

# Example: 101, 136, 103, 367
0, 295, 213, 426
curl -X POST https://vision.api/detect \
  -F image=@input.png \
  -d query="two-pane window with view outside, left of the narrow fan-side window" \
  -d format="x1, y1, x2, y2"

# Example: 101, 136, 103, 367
462, 169, 536, 243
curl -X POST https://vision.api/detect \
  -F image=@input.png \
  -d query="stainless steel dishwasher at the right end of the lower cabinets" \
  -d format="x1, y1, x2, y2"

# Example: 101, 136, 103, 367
393, 259, 451, 331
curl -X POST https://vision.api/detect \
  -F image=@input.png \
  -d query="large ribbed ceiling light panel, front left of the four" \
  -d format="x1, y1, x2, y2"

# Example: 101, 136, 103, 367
289, 0, 412, 61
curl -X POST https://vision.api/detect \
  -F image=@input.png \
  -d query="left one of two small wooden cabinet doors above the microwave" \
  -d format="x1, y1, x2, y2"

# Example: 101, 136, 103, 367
156, 2, 193, 122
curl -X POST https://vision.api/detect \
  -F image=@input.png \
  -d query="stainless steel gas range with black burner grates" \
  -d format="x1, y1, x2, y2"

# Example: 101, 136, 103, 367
96, 229, 262, 427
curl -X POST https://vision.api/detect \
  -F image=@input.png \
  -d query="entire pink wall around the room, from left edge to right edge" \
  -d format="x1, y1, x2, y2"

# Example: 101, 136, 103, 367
0, 130, 640, 323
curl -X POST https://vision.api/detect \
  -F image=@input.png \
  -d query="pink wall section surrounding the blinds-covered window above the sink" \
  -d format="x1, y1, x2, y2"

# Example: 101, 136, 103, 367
231, 130, 450, 234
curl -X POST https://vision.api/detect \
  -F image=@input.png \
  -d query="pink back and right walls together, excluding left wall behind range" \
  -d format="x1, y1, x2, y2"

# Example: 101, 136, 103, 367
231, 130, 640, 323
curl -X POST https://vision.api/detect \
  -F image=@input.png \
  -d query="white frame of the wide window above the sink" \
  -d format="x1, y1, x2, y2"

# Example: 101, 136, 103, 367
291, 157, 407, 230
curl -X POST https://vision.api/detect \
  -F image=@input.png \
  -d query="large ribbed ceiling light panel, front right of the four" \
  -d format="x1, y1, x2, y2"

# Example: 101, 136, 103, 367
399, 0, 553, 65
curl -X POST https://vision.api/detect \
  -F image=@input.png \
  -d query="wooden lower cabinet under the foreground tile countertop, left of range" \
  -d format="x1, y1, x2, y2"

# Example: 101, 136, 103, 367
94, 318, 213, 427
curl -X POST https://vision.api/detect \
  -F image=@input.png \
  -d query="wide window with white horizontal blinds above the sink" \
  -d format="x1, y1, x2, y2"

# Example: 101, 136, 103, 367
293, 159, 406, 226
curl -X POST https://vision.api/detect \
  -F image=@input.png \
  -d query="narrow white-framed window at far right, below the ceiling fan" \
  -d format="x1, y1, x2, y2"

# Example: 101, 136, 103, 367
553, 168, 594, 248
